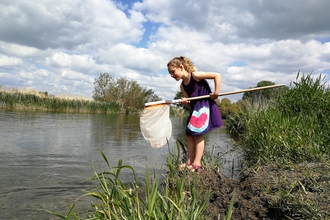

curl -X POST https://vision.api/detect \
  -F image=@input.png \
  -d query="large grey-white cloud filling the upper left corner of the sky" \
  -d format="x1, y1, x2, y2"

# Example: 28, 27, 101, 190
0, 0, 143, 50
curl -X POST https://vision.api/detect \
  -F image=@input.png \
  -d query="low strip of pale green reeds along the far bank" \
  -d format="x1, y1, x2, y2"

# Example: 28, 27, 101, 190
0, 89, 121, 113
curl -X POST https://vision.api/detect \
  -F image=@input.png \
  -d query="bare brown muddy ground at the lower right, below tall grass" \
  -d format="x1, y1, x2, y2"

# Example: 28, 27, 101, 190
187, 164, 330, 220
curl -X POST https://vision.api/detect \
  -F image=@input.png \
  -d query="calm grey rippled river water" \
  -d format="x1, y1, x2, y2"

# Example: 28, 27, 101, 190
0, 110, 241, 220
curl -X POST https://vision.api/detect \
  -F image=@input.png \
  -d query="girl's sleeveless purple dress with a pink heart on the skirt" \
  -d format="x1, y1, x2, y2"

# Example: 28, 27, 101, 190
182, 74, 222, 136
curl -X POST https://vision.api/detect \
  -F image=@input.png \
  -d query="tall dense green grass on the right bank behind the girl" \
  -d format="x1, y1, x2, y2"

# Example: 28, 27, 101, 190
227, 73, 330, 164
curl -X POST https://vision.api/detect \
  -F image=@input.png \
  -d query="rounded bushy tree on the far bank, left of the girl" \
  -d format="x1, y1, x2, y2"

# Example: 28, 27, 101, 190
93, 73, 160, 109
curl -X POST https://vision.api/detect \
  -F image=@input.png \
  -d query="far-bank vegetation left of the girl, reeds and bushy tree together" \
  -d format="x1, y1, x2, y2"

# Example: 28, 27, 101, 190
0, 73, 160, 114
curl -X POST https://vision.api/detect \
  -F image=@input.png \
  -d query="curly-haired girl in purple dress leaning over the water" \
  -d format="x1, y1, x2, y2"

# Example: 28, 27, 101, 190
167, 56, 222, 172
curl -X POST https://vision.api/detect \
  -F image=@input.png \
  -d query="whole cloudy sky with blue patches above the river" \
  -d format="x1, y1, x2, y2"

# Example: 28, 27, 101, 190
0, 0, 330, 102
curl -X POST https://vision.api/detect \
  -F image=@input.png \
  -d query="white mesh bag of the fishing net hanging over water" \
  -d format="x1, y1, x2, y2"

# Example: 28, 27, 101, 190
140, 105, 172, 148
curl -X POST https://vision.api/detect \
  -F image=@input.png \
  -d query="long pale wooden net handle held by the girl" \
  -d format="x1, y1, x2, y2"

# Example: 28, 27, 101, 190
144, 84, 285, 107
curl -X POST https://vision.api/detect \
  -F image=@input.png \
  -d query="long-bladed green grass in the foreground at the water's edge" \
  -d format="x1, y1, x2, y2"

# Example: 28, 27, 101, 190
48, 150, 234, 220
